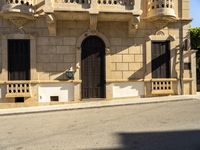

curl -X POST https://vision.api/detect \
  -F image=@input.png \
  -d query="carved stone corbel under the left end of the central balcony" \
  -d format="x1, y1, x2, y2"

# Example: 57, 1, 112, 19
46, 14, 56, 36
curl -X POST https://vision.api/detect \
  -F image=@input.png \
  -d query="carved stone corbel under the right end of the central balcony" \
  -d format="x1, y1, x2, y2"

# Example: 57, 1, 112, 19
128, 16, 140, 36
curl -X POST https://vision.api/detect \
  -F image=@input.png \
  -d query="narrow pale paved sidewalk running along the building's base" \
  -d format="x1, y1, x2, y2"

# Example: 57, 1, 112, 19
0, 95, 200, 116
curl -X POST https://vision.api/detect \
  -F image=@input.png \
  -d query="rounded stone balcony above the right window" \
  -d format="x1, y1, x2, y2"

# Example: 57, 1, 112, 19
147, 0, 176, 21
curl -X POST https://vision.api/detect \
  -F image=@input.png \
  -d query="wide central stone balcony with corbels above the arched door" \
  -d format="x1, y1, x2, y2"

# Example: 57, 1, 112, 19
44, 0, 142, 35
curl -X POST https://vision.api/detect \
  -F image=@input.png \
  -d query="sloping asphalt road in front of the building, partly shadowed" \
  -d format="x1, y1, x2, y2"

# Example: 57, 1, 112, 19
0, 100, 200, 150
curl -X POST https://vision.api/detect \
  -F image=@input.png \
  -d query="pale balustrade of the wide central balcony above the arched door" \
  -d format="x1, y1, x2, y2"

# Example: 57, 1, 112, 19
45, 0, 141, 14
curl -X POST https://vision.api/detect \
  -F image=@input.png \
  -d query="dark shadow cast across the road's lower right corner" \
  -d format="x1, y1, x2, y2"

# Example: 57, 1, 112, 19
88, 130, 200, 150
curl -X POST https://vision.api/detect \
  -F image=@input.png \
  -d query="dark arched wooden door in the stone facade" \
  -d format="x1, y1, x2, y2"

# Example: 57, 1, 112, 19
81, 36, 105, 99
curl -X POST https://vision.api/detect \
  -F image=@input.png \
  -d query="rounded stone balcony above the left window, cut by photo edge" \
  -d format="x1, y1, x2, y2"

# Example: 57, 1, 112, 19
0, 0, 35, 27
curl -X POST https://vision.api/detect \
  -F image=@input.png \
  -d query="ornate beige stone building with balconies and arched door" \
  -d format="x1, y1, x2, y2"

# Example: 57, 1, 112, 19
0, 0, 196, 103
